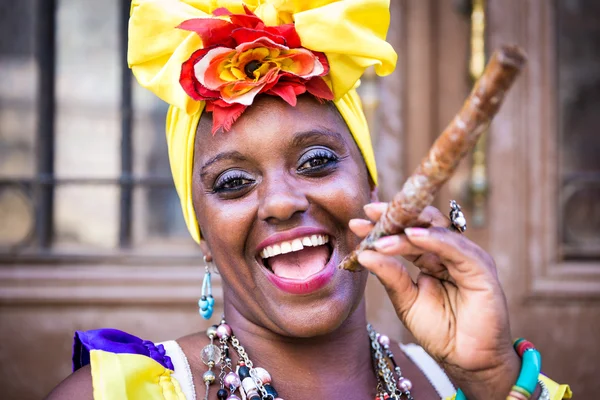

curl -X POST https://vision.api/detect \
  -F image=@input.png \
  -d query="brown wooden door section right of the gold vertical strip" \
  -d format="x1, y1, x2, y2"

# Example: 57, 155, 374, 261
487, 0, 600, 399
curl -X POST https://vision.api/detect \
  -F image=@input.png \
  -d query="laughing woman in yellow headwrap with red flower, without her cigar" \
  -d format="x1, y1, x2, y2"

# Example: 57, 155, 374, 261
44, 0, 569, 400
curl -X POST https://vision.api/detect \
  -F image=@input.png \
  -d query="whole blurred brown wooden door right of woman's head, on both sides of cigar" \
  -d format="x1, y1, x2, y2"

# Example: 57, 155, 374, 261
376, 0, 600, 399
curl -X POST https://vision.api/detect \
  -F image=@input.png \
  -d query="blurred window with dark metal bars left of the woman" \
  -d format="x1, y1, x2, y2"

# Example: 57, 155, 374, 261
0, 0, 199, 263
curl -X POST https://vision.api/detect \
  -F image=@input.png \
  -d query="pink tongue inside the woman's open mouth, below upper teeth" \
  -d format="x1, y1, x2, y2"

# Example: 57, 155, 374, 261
269, 246, 329, 280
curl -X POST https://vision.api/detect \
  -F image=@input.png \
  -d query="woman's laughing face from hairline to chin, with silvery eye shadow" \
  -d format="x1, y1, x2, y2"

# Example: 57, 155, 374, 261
193, 96, 372, 337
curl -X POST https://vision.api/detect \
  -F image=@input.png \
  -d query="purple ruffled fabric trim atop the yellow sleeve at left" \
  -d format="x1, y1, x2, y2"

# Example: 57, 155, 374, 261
73, 329, 175, 371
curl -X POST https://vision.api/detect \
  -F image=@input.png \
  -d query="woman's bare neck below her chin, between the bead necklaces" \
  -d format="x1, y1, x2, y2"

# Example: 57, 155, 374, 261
225, 300, 376, 399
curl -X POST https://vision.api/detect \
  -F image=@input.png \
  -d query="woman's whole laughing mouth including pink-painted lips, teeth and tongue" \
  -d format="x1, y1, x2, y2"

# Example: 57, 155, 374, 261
258, 228, 335, 294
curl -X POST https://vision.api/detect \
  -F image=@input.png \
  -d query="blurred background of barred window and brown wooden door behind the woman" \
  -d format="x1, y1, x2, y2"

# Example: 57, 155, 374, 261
0, 0, 600, 400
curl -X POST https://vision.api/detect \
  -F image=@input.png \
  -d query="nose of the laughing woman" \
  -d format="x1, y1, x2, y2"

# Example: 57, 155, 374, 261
258, 174, 309, 223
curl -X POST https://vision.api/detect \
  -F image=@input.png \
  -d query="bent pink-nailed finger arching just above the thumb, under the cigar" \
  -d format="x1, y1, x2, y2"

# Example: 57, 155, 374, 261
405, 228, 497, 289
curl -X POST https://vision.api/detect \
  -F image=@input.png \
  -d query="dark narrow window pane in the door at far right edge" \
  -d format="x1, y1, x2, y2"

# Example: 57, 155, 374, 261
556, 0, 600, 260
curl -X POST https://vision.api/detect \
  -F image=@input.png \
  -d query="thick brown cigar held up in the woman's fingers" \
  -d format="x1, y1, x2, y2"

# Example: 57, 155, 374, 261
339, 45, 526, 272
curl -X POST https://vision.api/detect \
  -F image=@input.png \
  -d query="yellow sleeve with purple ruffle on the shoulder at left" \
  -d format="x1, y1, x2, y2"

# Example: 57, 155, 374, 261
73, 329, 186, 400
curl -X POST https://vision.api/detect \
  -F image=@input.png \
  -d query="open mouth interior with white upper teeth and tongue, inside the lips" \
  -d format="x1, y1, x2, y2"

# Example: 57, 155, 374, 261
260, 235, 332, 280
